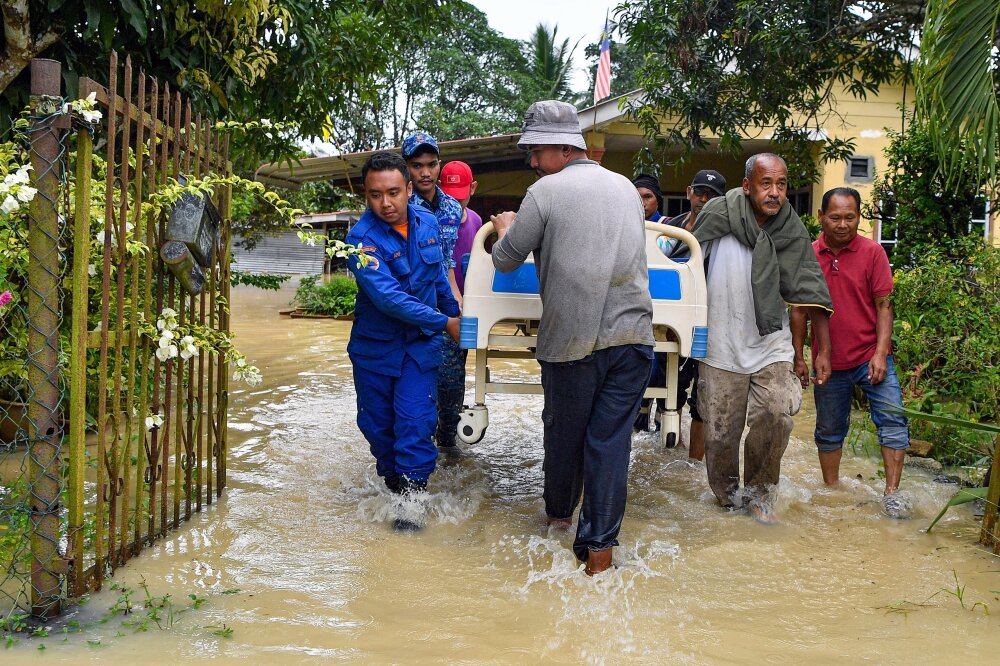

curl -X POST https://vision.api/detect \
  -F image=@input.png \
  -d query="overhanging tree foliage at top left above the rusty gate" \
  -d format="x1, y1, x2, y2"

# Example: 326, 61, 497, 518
0, 0, 451, 166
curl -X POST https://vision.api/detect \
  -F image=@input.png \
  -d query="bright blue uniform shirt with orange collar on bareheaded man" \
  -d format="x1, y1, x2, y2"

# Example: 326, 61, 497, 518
347, 205, 459, 377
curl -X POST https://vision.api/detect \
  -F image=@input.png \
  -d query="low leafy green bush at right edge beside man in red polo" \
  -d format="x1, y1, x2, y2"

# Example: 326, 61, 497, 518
893, 239, 1000, 464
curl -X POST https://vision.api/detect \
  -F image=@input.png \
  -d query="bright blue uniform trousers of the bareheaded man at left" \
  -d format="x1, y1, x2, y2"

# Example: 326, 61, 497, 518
354, 354, 437, 481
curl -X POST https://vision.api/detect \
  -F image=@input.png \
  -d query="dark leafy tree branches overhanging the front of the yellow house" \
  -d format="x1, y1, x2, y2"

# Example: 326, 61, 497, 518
616, 0, 923, 185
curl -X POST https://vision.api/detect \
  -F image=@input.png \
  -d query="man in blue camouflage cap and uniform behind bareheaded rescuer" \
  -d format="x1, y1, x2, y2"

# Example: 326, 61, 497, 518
400, 132, 465, 458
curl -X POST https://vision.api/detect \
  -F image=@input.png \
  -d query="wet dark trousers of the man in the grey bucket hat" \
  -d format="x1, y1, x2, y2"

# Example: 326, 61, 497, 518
540, 345, 653, 560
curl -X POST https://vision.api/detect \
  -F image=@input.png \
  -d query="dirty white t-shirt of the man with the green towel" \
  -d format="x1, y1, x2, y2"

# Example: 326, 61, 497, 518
703, 234, 795, 375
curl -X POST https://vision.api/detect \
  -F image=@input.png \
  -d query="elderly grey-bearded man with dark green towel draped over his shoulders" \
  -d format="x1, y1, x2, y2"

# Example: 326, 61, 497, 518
693, 153, 833, 524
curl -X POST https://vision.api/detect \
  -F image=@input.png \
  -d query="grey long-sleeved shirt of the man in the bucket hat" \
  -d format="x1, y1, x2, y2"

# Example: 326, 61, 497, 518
493, 160, 653, 363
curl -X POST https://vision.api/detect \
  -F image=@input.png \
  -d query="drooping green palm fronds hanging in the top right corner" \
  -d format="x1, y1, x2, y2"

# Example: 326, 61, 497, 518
916, 0, 1000, 188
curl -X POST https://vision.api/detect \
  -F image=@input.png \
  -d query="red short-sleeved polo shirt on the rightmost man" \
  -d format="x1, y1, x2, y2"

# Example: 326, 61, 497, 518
813, 234, 892, 370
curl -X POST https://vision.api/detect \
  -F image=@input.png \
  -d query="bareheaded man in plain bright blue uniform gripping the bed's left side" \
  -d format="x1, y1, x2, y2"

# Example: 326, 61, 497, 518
347, 152, 459, 504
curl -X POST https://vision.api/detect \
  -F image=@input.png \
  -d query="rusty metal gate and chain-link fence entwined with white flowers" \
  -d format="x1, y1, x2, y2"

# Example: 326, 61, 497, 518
0, 55, 231, 627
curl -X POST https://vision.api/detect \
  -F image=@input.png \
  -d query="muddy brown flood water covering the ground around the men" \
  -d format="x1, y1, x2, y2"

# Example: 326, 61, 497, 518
9, 285, 1000, 665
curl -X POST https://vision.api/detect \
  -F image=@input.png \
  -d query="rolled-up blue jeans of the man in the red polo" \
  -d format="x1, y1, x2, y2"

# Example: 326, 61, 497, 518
813, 356, 910, 453
